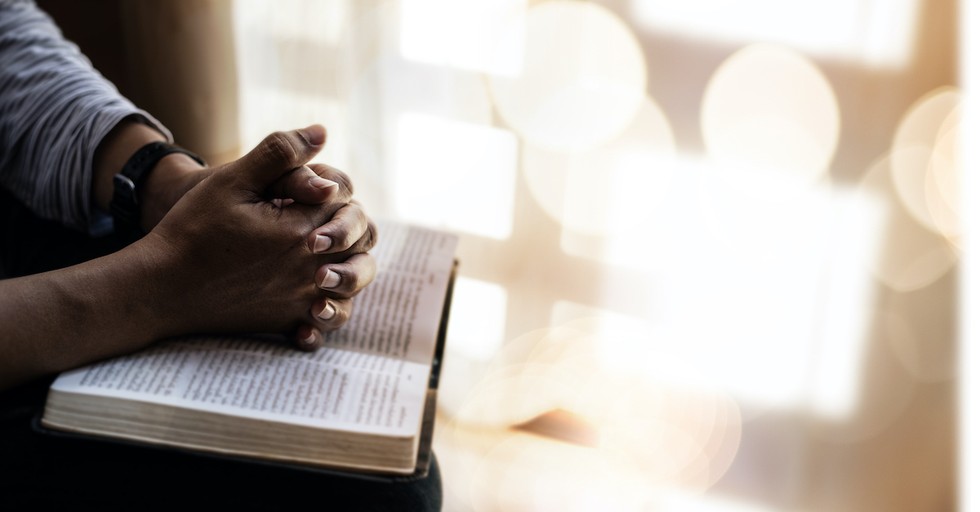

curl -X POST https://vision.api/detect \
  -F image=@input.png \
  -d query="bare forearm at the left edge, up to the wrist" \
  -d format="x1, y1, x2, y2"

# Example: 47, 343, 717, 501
0, 240, 173, 389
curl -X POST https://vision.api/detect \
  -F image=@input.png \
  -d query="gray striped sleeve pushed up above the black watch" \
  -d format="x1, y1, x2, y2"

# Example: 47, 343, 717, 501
0, 0, 173, 231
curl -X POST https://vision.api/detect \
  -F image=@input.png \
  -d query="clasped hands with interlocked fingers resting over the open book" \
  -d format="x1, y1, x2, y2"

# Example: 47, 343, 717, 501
137, 126, 377, 347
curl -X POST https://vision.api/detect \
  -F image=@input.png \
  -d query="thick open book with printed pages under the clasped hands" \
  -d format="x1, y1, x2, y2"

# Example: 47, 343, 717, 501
34, 223, 456, 475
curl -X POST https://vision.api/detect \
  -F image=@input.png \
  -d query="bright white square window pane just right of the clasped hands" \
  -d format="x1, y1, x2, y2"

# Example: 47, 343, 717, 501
392, 114, 517, 239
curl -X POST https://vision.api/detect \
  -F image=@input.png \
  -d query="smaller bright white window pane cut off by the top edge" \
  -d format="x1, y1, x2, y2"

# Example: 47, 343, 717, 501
401, 0, 527, 76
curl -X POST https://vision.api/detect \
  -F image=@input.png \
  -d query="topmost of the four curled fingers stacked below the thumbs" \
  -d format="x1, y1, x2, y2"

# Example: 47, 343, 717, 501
307, 201, 378, 254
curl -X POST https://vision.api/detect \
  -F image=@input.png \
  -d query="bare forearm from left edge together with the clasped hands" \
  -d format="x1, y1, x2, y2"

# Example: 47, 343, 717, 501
0, 126, 377, 389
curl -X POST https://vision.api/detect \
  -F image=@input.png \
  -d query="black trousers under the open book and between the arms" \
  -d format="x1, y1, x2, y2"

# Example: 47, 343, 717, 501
0, 192, 442, 511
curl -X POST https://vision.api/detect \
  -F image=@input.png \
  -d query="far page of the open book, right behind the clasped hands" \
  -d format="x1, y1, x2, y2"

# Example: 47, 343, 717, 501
327, 223, 457, 365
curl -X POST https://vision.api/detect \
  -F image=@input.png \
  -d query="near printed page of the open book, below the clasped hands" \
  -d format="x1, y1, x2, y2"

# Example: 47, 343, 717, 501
52, 338, 429, 435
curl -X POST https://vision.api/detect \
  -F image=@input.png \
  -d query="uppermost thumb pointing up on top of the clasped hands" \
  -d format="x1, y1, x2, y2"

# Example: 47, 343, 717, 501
229, 124, 327, 193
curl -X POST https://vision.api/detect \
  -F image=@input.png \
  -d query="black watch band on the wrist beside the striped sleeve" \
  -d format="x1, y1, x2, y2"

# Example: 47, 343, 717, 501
109, 141, 205, 237
